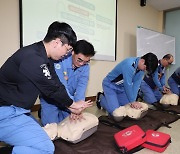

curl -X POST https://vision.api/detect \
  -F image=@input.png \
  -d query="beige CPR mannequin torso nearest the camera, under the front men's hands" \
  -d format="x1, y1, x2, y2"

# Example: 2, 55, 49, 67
43, 112, 99, 143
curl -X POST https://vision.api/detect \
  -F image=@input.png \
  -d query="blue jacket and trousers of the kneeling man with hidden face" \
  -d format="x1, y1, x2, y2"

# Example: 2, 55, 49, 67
100, 57, 144, 114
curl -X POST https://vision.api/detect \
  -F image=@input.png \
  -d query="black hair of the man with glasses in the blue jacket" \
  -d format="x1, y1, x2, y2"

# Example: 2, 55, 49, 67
74, 40, 95, 56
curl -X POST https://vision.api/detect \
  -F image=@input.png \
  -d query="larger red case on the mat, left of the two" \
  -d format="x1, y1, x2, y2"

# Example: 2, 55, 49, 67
114, 125, 146, 153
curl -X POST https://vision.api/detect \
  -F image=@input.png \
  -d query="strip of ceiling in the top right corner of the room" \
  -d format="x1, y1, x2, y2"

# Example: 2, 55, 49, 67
146, 0, 180, 11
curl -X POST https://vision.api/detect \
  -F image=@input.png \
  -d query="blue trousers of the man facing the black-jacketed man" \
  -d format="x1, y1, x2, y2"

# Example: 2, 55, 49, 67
41, 99, 69, 126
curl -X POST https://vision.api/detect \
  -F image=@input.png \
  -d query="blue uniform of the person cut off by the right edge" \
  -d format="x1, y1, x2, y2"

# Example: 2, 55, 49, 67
168, 67, 180, 96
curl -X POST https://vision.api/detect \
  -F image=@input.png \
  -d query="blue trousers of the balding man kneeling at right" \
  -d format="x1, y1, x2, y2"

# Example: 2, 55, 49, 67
140, 80, 163, 104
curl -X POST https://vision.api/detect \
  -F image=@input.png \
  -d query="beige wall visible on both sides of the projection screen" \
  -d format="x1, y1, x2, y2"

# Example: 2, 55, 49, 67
0, 0, 163, 96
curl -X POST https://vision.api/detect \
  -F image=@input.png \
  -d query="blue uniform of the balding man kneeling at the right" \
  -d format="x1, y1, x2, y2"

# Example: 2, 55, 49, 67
140, 61, 165, 104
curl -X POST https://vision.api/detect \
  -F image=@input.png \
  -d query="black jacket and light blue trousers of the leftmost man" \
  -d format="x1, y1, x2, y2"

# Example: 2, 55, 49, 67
0, 42, 73, 154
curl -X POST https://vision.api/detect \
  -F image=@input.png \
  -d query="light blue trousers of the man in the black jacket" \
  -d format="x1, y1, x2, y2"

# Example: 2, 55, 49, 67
0, 105, 54, 154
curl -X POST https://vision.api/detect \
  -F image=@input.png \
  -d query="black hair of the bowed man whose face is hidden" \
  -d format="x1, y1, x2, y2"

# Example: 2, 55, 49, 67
141, 52, 158, 74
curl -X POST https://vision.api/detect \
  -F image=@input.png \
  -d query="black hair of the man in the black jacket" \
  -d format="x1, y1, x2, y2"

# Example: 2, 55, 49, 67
44, 21, 77, 46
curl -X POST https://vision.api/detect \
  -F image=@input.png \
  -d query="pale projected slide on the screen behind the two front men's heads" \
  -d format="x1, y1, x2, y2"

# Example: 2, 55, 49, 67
22, 0, 116, 61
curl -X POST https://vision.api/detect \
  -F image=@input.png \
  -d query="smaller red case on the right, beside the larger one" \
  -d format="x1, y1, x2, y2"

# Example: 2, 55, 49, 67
142, 130, 171, 152
